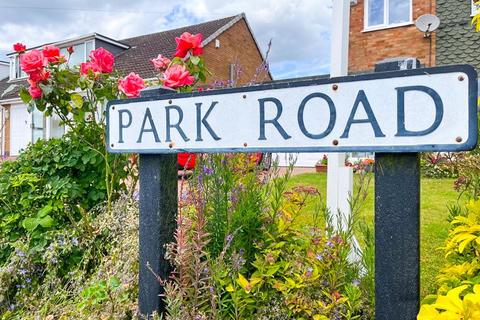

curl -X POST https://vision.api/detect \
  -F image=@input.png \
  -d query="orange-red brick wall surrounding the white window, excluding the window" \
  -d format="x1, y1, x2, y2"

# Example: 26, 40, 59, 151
349, 0, 435, 72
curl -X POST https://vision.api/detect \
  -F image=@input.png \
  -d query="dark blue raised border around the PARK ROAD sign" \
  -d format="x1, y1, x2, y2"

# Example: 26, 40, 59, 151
105, 64, 478, 154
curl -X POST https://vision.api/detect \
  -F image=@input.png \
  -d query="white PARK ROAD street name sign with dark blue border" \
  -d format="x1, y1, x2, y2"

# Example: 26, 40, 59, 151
107, 65, 477, 154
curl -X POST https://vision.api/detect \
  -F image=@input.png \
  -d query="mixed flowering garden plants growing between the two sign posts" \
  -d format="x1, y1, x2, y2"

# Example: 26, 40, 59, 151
162, 155, 373, 319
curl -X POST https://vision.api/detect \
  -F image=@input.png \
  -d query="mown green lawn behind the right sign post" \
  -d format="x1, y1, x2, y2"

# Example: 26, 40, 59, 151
290, 173, 458, 297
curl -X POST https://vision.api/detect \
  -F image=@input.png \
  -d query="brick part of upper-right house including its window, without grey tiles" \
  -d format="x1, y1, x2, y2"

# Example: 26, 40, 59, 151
349, 0, 436, 73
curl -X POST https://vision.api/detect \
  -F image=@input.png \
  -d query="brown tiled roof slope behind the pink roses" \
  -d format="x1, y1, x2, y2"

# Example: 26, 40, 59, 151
115, 16, 242, 78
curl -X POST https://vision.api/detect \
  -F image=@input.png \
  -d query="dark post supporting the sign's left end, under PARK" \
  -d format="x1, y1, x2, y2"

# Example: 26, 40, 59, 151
138, 85, 178, 316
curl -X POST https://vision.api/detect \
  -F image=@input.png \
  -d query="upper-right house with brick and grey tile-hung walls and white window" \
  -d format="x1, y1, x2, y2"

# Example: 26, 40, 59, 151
349, 0, 480, 73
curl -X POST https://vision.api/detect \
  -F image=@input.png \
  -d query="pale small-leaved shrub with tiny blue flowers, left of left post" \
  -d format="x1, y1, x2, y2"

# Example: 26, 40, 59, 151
0, 196, 138, 319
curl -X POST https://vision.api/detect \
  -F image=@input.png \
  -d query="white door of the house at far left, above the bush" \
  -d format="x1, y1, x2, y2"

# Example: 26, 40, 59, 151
10, 104, 32, 156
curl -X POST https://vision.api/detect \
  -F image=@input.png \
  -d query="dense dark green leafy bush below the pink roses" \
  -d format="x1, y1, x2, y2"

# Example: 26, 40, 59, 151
0, 127, 128, 269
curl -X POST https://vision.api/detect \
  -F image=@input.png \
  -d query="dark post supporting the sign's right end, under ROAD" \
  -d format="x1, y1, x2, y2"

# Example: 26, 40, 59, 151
375, 61, 420, 320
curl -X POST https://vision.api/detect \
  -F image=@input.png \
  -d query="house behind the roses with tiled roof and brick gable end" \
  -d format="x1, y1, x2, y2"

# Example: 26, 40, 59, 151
0, 14, 272, 157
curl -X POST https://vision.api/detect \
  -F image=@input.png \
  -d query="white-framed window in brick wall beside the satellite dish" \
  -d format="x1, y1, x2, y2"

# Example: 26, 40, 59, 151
365, 0, 412, 30
